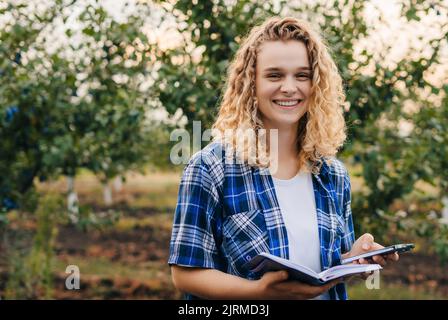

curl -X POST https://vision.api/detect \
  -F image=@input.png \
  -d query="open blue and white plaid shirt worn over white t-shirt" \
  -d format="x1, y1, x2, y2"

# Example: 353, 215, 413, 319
168, 142, 355, 300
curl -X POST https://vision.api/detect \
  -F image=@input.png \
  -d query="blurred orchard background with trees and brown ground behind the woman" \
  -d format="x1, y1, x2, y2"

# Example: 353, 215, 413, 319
0, 0, 448, 299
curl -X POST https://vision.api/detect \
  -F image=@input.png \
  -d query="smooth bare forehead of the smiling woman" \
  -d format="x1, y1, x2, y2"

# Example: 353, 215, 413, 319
257, 40, 310, 70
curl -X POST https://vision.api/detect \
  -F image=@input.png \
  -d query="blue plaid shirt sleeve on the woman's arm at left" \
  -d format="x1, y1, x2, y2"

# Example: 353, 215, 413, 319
168, 157, 222, 269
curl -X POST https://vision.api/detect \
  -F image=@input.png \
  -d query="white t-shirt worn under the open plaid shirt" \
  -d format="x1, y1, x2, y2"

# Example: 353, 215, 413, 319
272, 172, 329, 299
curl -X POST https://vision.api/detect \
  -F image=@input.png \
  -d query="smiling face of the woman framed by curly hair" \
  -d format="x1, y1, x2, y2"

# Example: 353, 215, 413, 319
255, 40, 311, 129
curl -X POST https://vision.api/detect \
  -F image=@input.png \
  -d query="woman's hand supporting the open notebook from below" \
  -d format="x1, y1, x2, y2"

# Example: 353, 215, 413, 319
256, 271, 343, 300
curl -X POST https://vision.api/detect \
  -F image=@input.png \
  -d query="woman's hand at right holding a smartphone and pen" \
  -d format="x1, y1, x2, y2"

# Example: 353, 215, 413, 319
343, 233, 399, 279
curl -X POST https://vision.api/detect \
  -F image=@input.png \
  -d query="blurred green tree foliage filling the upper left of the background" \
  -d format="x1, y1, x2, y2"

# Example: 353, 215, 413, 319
0, 0, 169, 221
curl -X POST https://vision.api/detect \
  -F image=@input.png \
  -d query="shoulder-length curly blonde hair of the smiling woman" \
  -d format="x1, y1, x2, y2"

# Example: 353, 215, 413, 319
212, 17, 346, 173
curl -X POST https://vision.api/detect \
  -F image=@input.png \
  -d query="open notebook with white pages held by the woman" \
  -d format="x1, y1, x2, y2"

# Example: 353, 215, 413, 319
244, 252, 382, 286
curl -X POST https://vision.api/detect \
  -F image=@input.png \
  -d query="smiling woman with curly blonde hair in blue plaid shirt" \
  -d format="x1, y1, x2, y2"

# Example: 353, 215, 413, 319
168, 18, 398, 299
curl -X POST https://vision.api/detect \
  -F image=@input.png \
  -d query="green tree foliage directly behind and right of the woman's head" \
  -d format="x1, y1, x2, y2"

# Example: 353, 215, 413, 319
156, 0, 448, 248
